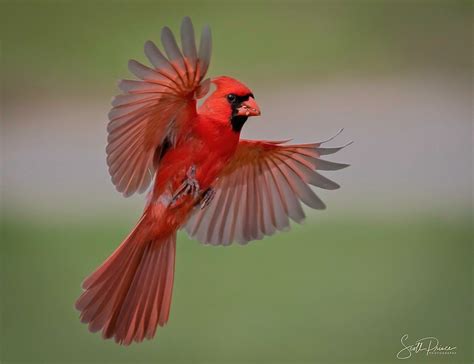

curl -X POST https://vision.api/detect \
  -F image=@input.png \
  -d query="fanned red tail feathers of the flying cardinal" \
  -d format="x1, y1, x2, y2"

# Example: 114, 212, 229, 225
76, 215, 176, 345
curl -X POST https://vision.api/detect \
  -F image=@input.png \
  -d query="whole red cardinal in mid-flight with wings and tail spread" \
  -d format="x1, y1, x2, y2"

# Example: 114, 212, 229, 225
76, 17, 347, 345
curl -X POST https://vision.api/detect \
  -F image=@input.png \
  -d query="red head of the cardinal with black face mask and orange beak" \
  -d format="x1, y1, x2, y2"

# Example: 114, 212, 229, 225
199, 76, 260, 132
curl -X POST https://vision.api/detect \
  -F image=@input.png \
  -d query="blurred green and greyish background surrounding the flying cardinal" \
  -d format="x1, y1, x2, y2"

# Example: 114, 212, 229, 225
0, 0, 474, 363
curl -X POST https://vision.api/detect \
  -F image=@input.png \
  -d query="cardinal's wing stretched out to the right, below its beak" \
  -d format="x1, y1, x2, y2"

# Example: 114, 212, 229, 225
185, 131, 348, 245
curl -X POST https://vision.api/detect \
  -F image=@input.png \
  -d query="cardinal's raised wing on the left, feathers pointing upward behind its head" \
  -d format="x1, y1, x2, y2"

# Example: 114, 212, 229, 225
106, 17, 211, 196
